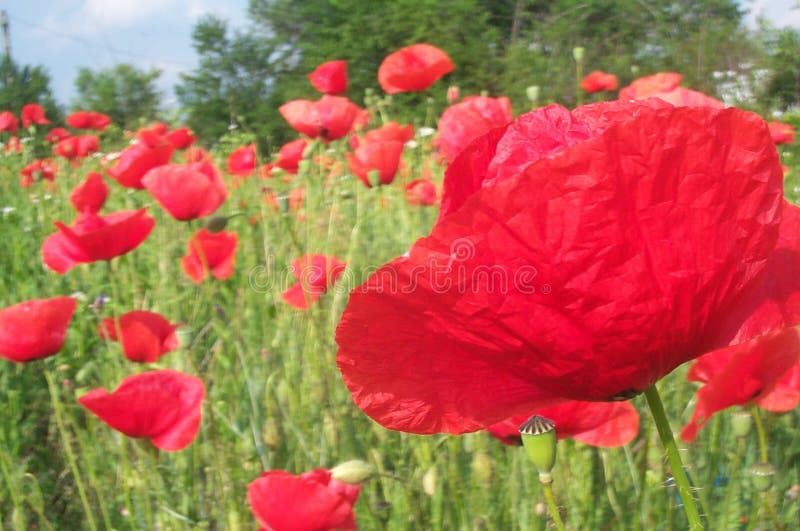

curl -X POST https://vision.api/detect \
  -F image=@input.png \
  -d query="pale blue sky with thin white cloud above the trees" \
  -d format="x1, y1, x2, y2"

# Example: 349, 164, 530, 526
6, 0, 800, 106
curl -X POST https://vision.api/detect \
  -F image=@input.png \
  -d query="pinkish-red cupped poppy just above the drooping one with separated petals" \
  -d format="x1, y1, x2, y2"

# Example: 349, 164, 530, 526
142, 162, 228, 221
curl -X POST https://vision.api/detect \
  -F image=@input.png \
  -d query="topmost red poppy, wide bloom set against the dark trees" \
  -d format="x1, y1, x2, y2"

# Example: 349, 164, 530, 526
378, 44, 456, 94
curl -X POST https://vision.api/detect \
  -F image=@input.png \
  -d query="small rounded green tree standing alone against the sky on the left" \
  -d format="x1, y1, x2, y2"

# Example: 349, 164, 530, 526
73, 64, 161, 129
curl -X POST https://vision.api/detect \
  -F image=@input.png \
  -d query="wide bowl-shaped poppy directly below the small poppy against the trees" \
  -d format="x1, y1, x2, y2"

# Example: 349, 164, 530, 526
278, 95, 361, 142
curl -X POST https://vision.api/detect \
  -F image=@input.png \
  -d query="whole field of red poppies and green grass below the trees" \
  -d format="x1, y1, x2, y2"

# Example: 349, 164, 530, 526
0, 44, 800, 531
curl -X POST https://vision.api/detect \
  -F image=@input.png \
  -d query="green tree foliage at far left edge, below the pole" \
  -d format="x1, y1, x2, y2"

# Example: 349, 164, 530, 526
0, 55, 61, 121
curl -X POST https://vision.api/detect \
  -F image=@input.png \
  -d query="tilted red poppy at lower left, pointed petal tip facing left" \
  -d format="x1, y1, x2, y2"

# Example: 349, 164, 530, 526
78, 369, 206, 452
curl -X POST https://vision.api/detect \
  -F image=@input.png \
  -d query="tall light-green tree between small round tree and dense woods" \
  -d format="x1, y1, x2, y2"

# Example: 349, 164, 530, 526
175, 15, 282, 148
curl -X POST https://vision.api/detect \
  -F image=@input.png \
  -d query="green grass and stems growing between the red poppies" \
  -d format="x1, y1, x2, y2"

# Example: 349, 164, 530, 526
0, 117, 800, 531
